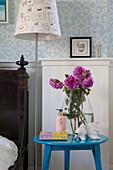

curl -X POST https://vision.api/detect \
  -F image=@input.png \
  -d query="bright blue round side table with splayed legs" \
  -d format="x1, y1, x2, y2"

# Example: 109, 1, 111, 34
33, 134, 108, 170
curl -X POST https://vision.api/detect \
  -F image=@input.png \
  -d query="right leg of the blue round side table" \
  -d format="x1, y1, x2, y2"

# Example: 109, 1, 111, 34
92, 144, 102, 170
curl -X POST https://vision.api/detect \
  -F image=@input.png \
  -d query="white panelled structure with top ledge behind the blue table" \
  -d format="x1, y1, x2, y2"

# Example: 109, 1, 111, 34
40, 58, 113, 170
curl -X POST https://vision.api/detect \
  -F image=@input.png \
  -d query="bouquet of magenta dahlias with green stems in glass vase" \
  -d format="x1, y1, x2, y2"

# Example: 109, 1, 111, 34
49, 66, 94, 133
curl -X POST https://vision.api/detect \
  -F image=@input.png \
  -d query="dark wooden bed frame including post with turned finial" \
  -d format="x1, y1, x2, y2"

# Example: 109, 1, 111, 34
0, 56, 29, 170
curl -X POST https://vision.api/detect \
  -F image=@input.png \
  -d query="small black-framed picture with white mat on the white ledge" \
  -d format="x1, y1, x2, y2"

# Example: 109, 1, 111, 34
70, 37, 92, 58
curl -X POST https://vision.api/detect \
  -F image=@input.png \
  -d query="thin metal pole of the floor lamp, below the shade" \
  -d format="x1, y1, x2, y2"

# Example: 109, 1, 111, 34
34, 33, 38, 170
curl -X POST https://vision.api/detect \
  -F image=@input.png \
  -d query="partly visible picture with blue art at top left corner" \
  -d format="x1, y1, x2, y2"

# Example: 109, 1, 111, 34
0, 0, 8, 24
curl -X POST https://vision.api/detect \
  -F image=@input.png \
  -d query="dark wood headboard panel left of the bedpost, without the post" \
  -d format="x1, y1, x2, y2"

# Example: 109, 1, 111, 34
0, 70, 19, 143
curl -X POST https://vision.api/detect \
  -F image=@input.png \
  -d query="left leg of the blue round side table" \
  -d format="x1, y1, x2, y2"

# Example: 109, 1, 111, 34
43, 145, 51, 170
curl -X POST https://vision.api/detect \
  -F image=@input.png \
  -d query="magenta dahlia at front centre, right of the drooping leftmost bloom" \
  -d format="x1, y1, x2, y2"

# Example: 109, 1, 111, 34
64, 75, 79, 90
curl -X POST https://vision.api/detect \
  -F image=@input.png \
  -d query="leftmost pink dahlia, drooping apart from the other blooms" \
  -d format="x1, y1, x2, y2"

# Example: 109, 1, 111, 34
49, 79, 63, 89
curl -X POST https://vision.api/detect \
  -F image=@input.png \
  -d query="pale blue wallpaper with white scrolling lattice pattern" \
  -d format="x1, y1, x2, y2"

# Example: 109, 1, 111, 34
0, 0, 113, 62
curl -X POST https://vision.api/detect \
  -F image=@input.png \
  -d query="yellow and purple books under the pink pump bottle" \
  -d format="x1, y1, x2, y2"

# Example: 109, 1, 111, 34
39, 130, 67, 140
